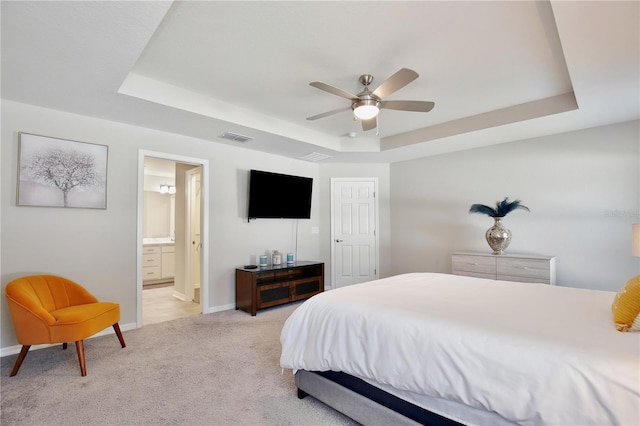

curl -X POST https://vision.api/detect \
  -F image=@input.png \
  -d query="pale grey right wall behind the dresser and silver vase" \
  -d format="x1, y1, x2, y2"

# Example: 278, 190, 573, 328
391, 121, 640, 291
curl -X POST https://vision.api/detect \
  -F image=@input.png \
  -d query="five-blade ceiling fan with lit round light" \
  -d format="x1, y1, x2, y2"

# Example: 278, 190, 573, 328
307, 68, 435, 131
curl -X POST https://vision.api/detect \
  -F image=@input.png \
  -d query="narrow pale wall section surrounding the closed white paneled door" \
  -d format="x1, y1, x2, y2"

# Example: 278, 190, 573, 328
319, 163, 391, 287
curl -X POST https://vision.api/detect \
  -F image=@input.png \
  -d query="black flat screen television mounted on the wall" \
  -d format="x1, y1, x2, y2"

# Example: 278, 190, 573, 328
249, 170, 313, 219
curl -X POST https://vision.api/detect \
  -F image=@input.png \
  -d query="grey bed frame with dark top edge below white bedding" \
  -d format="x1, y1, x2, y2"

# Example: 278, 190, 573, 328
295, 370, 460, 426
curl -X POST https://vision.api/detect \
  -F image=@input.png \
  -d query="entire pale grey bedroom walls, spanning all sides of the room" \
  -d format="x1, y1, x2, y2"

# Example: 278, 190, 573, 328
0, 100, 640, 349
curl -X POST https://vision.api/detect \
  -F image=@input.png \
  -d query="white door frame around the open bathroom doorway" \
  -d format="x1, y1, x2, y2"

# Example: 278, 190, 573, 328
136, 149, 210, 328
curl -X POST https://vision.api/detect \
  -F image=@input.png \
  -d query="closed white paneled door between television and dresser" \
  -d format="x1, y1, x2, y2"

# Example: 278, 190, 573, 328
331, 178, 378, 288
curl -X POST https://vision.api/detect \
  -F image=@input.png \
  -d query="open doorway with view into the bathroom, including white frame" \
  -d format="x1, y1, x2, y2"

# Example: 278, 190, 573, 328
137, 151, 208, 327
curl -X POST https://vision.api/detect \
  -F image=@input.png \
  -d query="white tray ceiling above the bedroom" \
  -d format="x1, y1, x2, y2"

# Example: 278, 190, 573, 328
1, 1, 640, 162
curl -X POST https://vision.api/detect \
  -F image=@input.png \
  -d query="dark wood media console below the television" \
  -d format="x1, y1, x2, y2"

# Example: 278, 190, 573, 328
236, 261, 324, 316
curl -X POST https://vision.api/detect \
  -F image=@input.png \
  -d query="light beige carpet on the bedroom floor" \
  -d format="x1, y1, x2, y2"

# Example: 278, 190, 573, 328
0, 303, 355, 426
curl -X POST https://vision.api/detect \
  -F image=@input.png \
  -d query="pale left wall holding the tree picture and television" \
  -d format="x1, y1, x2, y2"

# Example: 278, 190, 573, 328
0, 100, 323, 348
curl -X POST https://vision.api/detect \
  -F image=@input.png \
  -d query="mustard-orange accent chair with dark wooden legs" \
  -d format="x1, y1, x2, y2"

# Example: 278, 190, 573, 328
5, 275, 126, 376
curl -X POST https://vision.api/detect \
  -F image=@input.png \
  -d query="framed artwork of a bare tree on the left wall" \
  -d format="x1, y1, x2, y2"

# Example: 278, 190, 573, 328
17, 133, 108, 209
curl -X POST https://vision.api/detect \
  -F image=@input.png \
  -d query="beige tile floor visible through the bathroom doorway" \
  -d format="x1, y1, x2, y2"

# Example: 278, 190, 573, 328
142, 285, 200, 326
